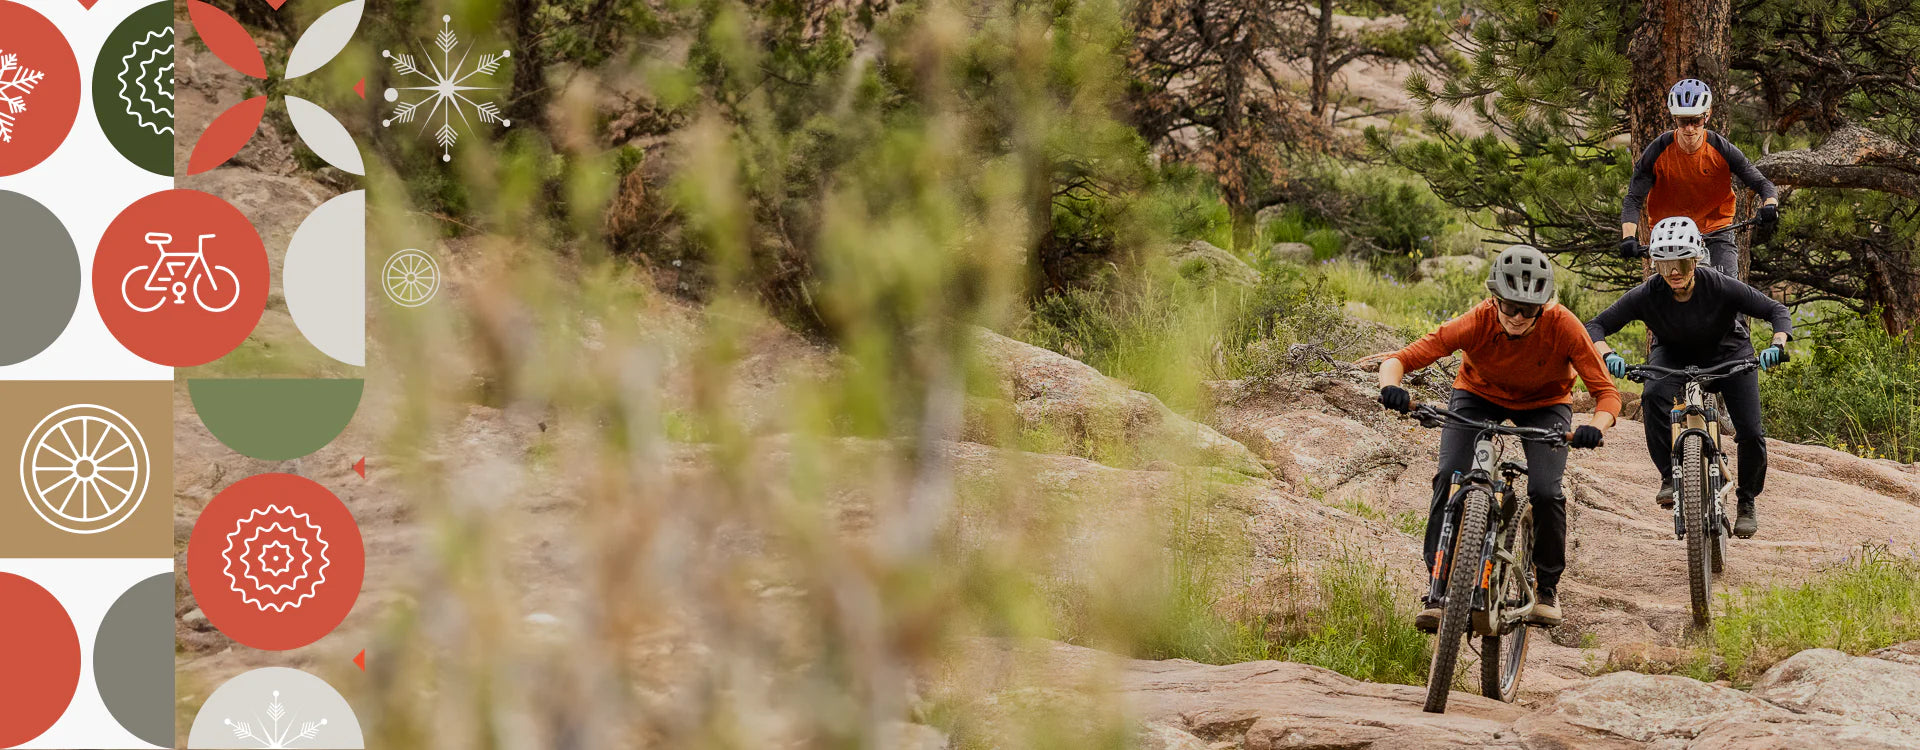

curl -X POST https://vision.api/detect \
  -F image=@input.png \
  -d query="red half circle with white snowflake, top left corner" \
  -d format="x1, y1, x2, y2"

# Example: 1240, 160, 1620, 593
0, 0, 81, 175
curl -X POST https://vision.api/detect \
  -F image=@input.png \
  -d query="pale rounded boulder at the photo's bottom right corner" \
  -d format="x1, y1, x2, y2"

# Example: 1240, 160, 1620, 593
1753, 648, 1920, 737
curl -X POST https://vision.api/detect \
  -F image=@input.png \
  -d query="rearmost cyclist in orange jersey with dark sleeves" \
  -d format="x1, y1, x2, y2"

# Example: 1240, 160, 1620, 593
1620, 79, 1780, 278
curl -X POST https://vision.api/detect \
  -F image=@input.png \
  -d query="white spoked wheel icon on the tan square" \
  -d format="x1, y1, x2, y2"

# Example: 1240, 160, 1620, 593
19, 405, 150, 533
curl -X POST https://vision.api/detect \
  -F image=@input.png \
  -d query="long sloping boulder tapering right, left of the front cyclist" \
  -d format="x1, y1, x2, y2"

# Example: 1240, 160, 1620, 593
975, 328, 1271, 478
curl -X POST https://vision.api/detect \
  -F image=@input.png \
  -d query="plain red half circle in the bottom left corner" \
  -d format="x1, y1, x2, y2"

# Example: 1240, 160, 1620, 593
0, 574, 81, 748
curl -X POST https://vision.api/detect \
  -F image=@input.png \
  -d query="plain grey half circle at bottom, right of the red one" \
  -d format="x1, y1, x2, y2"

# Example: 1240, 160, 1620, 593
94, 574, 173, 746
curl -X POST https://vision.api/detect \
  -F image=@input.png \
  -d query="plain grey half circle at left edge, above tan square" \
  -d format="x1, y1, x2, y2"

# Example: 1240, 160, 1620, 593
0, 190, 81, 366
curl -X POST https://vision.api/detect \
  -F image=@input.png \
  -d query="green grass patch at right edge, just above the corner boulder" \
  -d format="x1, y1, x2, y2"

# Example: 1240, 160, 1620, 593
1701, 545, 1920, 683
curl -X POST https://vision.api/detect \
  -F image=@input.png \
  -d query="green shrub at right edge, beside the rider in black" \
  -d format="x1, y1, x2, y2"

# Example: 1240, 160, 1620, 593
1753, 311, 1920, 462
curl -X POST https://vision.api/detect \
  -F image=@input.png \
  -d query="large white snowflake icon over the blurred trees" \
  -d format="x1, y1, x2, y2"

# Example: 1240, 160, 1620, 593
380, 15, 513, 161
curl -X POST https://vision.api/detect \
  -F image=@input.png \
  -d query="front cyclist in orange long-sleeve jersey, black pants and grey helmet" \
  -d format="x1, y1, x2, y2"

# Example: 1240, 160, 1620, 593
1380, 246, 1620, 633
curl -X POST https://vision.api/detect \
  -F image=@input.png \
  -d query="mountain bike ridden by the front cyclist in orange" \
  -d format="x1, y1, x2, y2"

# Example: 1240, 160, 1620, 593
1407, 405, 1567, 714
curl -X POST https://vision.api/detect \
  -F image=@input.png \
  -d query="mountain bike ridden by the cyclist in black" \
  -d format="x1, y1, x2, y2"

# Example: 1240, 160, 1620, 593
1626, 357, 1761, 627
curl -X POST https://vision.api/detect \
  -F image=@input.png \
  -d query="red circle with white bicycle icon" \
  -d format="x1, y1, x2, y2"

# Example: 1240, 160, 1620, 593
93, 190, 267, 366
